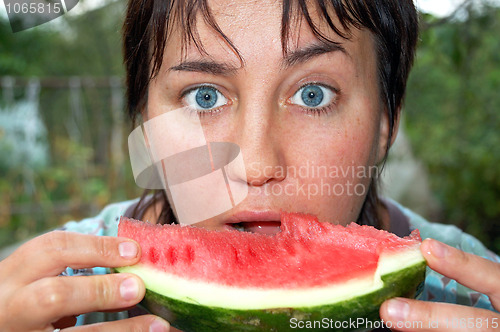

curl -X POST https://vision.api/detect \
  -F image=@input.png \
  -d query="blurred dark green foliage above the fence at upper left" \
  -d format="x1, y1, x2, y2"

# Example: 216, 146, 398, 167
0, 0, 124, 77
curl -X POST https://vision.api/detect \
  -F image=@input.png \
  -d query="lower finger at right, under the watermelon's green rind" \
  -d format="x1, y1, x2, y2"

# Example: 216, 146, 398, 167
380, 298, 500, 331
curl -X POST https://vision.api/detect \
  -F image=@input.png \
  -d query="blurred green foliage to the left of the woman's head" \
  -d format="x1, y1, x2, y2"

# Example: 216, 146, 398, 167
0, 2, 141, 247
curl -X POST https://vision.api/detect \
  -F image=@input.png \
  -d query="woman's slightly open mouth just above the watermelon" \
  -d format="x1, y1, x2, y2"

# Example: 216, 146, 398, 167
226, 211, 281, 235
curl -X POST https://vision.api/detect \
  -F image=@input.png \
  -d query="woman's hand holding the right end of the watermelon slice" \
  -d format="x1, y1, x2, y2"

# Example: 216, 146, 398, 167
380, 239, 500, 331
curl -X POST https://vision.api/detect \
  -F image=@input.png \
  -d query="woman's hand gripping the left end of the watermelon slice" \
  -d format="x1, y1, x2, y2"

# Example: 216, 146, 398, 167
0, 231, 169, 332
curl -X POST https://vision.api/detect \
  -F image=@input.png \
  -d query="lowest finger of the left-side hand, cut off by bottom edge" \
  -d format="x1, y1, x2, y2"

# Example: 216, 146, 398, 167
64, 315, 173, 332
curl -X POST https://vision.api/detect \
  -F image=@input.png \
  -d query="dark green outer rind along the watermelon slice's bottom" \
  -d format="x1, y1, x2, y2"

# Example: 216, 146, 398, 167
125, 261, 426, 332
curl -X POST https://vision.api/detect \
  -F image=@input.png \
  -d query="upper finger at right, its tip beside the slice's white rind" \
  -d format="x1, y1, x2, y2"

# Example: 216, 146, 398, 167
420, 239, 500, 309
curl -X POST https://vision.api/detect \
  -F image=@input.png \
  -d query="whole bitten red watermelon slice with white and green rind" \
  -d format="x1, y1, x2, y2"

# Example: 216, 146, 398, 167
118, 213, 425, 331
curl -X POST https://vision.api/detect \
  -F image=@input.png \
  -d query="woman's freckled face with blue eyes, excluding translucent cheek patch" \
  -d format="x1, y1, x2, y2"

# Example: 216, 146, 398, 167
147, 0, 388, 232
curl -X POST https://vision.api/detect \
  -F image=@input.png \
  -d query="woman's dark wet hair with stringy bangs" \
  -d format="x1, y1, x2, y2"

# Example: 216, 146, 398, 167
123, 0, 418, 226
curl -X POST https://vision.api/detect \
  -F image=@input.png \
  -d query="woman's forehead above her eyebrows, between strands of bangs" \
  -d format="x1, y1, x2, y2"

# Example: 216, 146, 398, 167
162, 0, 373, 68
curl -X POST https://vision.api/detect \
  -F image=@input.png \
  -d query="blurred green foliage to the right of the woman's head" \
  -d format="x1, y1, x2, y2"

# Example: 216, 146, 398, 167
405, 6, 500, 252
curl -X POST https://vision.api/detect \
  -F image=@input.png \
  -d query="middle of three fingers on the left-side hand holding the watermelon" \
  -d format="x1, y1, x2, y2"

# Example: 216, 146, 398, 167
8, 273, 146, 329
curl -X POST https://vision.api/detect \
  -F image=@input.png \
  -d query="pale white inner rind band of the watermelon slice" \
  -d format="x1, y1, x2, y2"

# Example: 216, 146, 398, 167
119, 246, 424, 310
